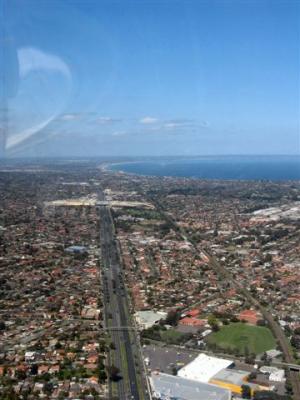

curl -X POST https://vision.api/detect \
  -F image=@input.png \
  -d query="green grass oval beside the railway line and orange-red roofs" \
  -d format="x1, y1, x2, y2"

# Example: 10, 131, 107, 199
206, 322, 276, 354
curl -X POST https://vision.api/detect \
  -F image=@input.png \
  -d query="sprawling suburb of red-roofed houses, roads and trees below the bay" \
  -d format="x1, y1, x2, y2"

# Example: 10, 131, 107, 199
0, 160, 300, 400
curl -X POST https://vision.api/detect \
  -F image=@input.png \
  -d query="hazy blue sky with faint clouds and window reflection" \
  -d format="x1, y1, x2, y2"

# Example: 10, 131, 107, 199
0, 0, 300, 156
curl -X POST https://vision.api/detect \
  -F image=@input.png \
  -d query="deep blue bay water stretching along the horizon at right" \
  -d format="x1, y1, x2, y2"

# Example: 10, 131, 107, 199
109, 156, 300, 181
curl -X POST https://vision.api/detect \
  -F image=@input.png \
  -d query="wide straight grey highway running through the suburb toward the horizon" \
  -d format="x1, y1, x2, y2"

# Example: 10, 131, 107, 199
98, 195, 146, 400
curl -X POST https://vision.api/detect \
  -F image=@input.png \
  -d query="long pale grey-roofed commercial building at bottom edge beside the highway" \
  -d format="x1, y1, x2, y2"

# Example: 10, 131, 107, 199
150, 373, 231, 400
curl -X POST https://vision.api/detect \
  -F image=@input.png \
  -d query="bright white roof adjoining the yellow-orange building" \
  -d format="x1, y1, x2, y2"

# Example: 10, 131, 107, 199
178, 354, 233, 382
